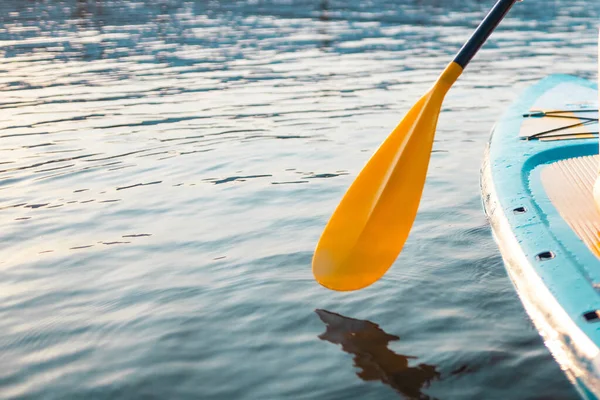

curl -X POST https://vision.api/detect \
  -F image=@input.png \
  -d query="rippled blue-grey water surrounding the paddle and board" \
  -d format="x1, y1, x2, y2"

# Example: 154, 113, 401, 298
0, 0, 600, 400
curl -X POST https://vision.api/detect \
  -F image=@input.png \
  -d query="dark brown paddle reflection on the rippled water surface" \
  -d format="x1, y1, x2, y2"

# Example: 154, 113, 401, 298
315, 310, 440, 399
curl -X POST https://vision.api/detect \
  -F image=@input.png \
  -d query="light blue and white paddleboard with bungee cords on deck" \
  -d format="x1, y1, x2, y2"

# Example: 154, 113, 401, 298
481, 75, 600, 399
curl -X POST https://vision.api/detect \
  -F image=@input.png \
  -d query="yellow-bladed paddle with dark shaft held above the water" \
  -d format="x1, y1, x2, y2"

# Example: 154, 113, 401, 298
312, 0, 518, 291
